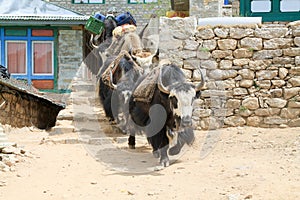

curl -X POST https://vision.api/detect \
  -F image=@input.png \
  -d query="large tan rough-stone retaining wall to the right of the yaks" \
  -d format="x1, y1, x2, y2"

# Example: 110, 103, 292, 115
159, 17, 300, 129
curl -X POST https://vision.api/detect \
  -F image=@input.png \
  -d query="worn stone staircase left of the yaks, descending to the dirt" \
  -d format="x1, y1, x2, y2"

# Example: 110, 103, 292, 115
46, 74, 141, 145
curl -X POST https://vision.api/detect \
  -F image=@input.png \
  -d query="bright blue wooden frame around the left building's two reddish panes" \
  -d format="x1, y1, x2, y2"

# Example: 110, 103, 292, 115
0, 28, 56, 84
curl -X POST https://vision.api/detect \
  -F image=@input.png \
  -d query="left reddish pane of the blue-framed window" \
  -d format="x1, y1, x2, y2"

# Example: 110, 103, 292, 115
6, 41, 27, 74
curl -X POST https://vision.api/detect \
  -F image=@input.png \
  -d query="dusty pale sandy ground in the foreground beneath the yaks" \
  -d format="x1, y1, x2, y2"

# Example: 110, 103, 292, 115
0, 127, 300, 200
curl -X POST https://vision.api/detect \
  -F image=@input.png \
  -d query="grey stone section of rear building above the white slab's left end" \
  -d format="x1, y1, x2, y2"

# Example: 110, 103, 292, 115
190, 0, 224, 18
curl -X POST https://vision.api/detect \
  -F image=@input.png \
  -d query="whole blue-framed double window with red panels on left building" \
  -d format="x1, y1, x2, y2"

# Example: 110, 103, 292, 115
0, 27, 58, 89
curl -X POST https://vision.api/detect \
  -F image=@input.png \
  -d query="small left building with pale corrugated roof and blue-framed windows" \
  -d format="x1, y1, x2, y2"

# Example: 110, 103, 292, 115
0, 0, 88, 90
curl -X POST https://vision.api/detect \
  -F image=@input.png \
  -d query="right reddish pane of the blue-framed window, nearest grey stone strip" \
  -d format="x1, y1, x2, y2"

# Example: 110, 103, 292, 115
32, 41, 53, 74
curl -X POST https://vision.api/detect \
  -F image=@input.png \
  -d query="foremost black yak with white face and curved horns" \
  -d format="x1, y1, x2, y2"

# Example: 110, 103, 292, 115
128, 63, 204, 167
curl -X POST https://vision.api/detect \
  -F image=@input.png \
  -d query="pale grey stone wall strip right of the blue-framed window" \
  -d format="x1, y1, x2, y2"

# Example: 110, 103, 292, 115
57, 30, 83, 90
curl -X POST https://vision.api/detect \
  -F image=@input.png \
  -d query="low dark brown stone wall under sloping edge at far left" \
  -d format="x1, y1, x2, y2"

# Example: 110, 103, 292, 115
0, 79, 64, 129
